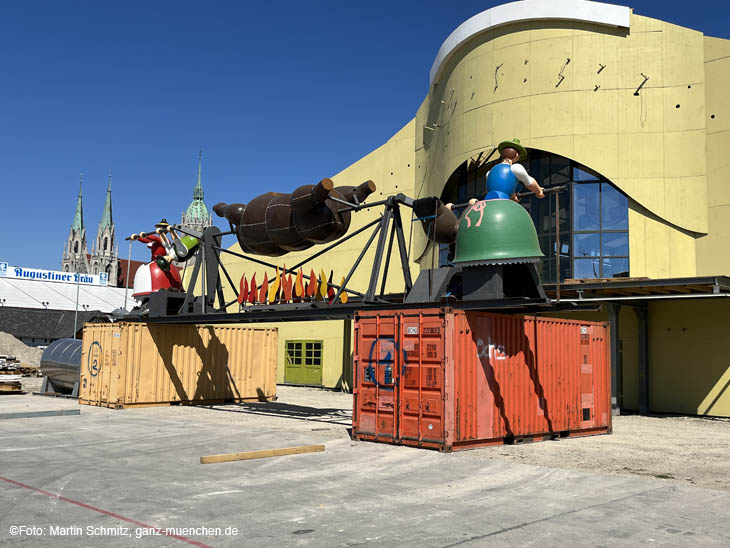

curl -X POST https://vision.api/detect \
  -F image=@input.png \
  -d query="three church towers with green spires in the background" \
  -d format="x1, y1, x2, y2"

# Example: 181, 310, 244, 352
61, 152, 212, 287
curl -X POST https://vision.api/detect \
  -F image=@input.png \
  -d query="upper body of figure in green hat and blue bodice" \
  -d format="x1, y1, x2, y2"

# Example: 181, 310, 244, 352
484, 139, 545, 201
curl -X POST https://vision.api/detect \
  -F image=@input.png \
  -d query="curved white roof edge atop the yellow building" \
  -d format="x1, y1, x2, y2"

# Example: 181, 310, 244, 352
429, 0, 631, 85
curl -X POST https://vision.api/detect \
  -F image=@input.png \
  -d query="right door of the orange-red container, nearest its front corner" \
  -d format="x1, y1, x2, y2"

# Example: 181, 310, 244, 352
397, 314, 446, 447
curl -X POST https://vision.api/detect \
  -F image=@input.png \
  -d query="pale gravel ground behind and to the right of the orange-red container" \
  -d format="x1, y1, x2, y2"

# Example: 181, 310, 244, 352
125, 386, 730, 491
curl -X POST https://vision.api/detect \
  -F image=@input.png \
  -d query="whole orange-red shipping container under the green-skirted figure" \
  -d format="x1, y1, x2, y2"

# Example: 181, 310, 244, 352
353, 308, 611, 451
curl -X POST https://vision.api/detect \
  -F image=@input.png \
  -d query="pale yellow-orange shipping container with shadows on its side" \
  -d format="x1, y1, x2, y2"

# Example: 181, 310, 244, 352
79, 322, 277, 408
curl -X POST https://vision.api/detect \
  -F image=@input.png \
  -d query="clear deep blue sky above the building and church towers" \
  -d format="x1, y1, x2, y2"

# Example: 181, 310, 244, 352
0, 0, 730, 269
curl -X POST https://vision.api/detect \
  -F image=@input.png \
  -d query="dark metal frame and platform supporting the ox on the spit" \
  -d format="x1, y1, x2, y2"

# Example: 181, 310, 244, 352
124, 194, 574, 324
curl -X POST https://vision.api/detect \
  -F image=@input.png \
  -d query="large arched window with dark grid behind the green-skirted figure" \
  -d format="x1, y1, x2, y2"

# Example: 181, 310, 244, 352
440, 151, 629, 282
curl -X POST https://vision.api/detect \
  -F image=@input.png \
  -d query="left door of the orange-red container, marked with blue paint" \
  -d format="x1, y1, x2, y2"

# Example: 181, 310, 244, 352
353, 315, 399, 443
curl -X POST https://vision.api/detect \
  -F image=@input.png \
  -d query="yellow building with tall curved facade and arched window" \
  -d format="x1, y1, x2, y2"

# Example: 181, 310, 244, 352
219, 0, 730, 416
